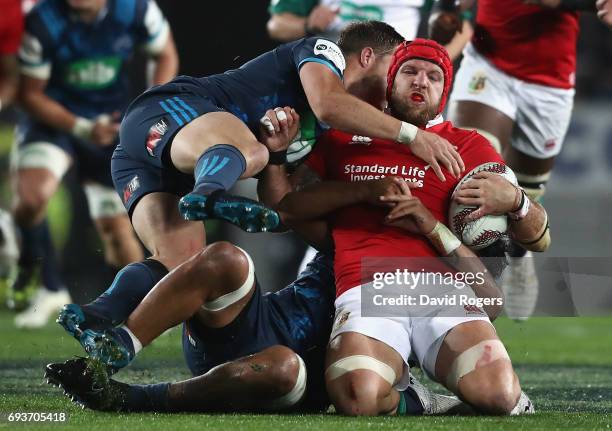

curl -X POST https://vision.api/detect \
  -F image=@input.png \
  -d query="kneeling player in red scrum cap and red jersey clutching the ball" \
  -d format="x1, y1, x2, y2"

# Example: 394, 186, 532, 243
279, 40, 546, 415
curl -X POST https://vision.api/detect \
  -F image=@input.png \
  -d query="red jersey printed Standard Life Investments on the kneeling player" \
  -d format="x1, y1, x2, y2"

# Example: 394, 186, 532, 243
306, 121, 502, 296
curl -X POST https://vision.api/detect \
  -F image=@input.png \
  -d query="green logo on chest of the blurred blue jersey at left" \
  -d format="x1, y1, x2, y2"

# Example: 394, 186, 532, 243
66, 57, 121, 90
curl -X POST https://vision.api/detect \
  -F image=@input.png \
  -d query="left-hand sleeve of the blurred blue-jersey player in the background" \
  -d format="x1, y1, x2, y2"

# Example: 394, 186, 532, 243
18, 12, 53, 80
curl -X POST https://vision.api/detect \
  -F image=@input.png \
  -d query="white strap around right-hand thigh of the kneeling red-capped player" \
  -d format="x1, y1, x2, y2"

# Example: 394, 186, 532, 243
446, 339, 510, 393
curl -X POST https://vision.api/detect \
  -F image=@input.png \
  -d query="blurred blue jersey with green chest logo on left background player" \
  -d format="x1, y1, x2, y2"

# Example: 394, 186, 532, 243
19, 0, 169, 118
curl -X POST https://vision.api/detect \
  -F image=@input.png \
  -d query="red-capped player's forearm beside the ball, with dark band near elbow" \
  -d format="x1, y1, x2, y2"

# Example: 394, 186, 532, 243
510, 202, 550, 252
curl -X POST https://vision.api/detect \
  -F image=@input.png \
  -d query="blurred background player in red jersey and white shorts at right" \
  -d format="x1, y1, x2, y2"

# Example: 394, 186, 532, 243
442, 0, 595, 319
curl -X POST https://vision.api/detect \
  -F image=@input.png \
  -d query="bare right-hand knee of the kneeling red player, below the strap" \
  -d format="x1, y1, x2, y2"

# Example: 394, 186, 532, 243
461, 360, 521, 415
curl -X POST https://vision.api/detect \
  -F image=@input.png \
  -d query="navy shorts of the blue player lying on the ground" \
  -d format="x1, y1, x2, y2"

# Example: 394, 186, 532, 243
183, 253, 335, 411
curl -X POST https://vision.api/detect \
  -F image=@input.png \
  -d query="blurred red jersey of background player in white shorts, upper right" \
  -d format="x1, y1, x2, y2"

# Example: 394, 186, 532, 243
472, 0, 578, 89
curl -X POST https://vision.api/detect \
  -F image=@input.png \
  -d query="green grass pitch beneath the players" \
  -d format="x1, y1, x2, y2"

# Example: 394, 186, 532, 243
0, 311, 612, 431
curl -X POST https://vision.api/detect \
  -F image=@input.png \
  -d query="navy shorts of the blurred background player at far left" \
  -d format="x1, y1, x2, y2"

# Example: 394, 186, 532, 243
16, 118, 115, 187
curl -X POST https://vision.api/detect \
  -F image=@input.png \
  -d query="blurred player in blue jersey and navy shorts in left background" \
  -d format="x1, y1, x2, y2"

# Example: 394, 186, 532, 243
13, 0, 178, 327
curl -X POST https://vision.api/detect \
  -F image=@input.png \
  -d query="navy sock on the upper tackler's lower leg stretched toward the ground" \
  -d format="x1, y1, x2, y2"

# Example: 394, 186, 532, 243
84, 259, 168, 325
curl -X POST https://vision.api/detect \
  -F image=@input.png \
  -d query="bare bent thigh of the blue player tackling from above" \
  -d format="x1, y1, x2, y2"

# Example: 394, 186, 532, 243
170, 112, 262, 173
